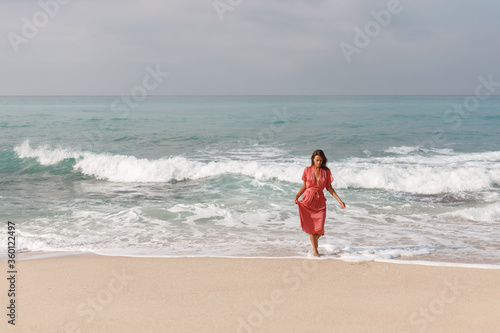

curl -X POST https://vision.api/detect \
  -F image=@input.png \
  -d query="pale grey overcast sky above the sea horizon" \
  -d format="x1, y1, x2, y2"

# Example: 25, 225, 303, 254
0, 0, 500, 95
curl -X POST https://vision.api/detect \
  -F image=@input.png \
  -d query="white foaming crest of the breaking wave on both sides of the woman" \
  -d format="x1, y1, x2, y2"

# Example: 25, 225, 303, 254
14, 141, 500, 194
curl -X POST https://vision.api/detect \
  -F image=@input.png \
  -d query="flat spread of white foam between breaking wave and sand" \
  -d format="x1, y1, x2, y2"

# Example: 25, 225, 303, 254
0, 197, 498, 262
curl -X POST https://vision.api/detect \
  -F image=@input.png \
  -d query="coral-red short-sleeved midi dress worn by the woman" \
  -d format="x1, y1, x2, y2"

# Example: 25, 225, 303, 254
298, 165, 333, 235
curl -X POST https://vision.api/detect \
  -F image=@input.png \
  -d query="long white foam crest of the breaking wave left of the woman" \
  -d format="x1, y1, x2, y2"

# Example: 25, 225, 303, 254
14, 141, 302, 183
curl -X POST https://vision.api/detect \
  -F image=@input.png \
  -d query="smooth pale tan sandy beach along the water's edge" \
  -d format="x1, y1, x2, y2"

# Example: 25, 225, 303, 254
0, 256, 500, 332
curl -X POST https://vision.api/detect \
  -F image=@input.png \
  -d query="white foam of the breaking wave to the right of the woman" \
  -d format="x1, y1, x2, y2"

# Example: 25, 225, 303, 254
334, 152, 500, 194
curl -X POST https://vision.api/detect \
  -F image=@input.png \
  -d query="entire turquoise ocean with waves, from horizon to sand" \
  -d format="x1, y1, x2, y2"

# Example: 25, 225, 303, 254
0, 96, 500, 265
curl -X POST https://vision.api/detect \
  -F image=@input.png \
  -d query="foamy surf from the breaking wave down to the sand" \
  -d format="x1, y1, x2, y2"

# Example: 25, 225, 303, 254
4, 137, 500, 264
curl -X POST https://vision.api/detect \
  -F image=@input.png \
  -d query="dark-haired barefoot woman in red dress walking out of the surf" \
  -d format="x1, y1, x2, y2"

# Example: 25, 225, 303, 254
295, 149, 345, 257
